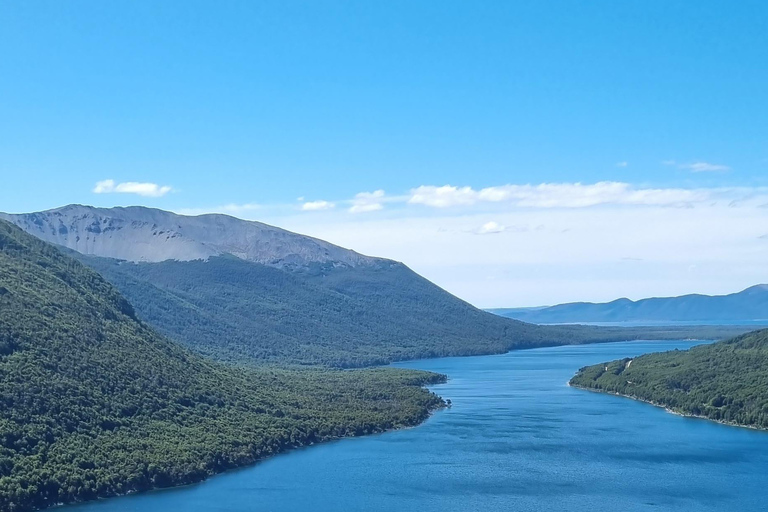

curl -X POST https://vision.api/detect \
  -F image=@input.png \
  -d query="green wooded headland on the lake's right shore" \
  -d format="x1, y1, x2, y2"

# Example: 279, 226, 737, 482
571, 330, 768, 429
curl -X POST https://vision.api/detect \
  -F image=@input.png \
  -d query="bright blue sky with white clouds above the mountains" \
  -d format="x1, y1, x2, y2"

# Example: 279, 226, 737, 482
0, 0, 768, 306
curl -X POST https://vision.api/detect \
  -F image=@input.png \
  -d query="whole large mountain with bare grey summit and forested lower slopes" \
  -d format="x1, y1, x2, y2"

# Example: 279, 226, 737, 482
6, 206, 744, 367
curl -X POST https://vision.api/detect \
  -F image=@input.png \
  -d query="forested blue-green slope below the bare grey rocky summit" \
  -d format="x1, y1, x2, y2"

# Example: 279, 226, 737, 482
71, 251, 746, 368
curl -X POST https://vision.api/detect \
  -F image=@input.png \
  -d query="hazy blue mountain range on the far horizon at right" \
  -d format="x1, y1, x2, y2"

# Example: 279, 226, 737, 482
489, 284, 768, 324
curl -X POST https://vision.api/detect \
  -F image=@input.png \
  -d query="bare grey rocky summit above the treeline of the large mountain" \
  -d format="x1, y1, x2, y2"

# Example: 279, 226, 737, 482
0, 205, 386, 267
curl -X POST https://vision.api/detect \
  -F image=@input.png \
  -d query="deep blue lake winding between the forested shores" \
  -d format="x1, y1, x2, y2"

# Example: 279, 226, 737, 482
62, 341, 768, 512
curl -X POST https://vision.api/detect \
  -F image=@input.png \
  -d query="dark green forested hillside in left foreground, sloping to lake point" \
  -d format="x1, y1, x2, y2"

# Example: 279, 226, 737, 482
0, 221, 444, 512
